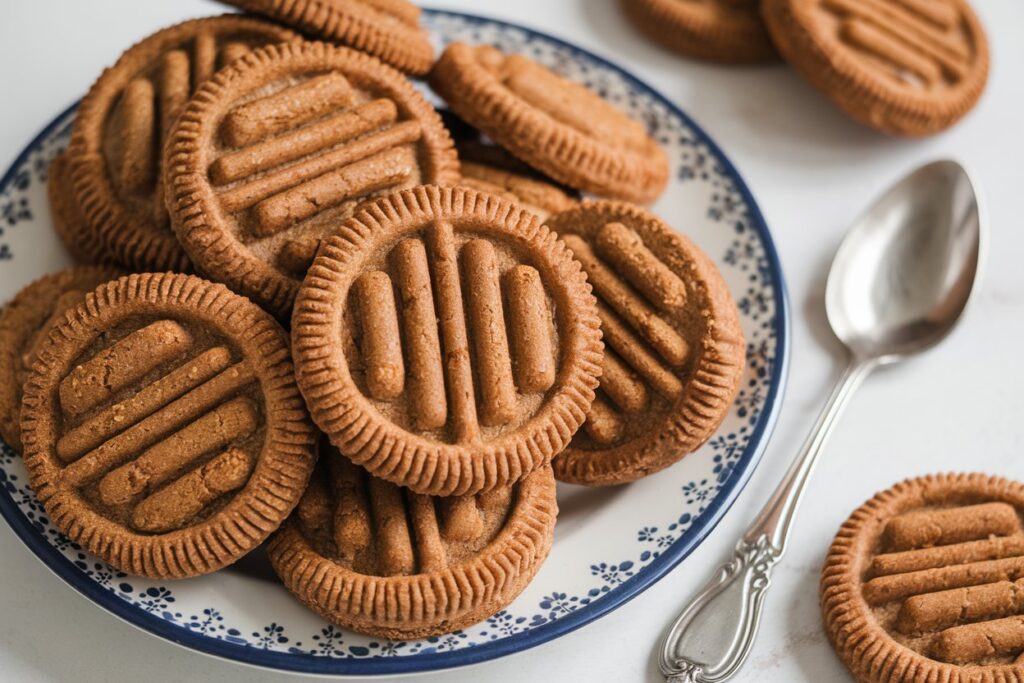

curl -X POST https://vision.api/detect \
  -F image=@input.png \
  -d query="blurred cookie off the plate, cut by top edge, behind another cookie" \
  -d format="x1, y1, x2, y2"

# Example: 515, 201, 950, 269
621, 0, 778, 63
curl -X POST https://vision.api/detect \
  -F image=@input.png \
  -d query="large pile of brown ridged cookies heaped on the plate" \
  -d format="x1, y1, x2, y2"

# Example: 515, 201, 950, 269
0, 0, 744, 638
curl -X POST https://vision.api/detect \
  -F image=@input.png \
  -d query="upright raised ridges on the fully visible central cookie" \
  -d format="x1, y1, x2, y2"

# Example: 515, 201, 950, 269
352, 221, 557, 442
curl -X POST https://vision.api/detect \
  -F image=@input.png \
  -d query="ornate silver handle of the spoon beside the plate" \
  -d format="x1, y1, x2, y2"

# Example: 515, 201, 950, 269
660, 359, 874, 683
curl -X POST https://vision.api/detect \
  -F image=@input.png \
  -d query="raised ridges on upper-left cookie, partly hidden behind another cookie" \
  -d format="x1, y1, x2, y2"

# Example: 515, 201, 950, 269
118, 31, 258, 227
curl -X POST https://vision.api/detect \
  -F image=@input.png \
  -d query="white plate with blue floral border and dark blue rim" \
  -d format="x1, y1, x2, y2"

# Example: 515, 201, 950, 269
0, 10, 788, 676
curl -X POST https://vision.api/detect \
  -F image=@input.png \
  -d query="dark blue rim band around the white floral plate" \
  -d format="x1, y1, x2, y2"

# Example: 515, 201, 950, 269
0, 7, 791, 676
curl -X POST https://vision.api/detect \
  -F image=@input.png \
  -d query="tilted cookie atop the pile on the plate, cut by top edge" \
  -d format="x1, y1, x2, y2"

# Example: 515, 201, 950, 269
224, 0, 434, 76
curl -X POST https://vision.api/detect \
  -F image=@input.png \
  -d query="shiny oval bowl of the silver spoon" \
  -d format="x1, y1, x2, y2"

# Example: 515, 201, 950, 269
825, 161, 982, 362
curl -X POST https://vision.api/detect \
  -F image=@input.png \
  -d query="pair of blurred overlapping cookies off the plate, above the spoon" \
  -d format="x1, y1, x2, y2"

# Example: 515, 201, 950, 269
622, 0, 989, 136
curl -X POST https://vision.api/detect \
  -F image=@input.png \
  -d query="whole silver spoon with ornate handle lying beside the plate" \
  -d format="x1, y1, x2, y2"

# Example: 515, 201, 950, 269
660, 161, 984, 683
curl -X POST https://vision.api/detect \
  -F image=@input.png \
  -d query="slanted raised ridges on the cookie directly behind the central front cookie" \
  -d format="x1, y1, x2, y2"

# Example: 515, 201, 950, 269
209, 72, 423, 274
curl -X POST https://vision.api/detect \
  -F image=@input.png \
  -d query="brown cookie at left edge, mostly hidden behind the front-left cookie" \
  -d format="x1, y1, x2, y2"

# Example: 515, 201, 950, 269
0, 266, 121, 453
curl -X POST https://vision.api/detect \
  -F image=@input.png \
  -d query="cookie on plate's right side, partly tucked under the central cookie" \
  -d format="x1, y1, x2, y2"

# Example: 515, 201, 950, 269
547, 201, 745, 484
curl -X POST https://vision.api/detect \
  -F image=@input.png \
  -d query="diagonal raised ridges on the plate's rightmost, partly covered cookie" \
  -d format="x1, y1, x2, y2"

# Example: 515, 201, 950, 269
562, 222, 689, 445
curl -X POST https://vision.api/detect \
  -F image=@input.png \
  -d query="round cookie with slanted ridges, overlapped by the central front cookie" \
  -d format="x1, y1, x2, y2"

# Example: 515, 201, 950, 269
167, 43, 459, 321
